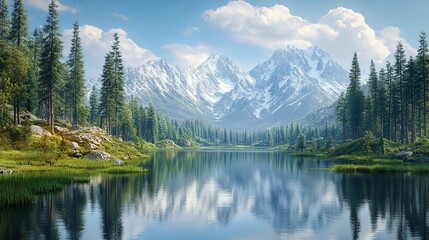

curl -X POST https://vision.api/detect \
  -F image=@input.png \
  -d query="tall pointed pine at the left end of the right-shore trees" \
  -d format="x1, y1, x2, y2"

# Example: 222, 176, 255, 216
346, 53, 365, 139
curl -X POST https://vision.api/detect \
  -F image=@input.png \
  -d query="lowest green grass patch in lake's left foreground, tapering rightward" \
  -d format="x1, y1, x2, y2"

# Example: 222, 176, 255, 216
0, 173, 89, 206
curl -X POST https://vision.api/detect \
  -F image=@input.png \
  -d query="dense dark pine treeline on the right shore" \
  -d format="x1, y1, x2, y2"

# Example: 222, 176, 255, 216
336, 33, 429, 144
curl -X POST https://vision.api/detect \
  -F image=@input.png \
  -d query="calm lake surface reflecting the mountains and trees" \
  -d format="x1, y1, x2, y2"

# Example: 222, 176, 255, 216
0, 150, 429, 240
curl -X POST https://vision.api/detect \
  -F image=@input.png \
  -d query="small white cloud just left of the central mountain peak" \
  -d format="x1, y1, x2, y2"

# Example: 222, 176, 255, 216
162, 43, 210, 68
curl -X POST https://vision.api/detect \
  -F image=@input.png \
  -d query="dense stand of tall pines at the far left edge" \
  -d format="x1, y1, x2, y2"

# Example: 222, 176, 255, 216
0, 0, 89, 133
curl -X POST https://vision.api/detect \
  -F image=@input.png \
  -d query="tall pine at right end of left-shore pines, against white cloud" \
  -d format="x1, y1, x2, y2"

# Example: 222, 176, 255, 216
112, 33, 125, 137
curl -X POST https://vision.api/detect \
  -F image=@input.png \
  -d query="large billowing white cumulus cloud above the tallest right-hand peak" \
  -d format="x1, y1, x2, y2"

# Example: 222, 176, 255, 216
203, 1, 415, 68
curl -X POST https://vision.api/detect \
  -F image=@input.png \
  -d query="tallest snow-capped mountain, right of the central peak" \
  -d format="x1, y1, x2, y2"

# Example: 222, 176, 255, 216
212, 46, 348, 128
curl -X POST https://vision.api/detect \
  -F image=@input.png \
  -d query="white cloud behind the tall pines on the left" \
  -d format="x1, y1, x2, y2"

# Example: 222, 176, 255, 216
63, 25, 157, 77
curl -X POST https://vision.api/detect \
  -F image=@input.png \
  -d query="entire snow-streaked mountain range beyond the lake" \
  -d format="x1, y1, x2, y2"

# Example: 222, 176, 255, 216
88, 46, 349, 130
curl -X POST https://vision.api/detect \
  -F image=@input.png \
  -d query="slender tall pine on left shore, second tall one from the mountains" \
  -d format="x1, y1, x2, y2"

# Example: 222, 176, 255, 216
67, 22, 85, 125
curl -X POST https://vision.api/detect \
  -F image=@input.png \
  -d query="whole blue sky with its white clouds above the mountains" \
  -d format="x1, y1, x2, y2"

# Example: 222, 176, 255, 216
21, 0, 429, 76
